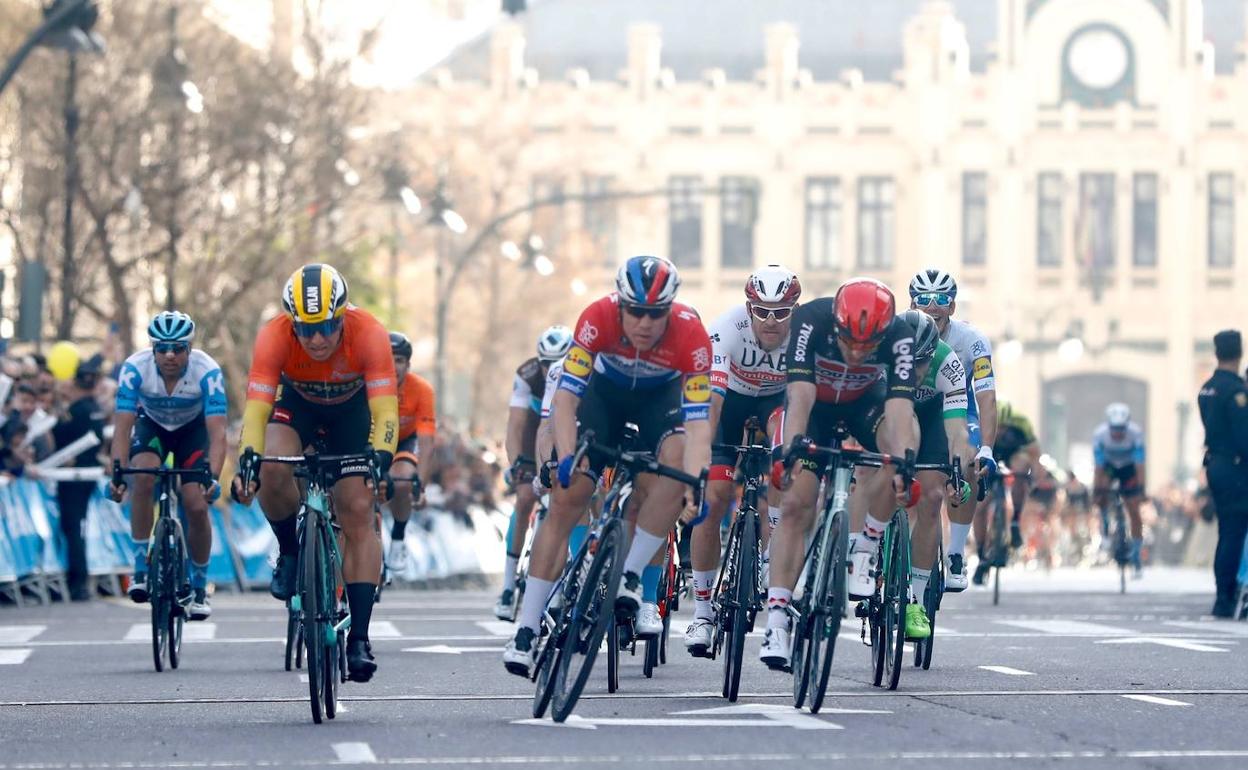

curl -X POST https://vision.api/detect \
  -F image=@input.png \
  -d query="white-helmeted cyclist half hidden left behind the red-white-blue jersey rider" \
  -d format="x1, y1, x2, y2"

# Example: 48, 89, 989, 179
494, 324, 572, 620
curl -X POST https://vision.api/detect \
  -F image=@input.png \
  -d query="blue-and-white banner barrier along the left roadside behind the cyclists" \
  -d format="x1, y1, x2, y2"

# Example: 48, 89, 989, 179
0, 479, 509, 604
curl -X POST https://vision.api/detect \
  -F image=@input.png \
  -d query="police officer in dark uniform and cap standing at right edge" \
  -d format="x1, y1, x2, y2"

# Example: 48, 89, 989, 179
1198, 329, 1248, 618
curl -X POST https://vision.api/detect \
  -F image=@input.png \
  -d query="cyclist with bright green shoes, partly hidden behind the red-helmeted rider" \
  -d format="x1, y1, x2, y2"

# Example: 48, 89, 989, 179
902, 311, 975, 639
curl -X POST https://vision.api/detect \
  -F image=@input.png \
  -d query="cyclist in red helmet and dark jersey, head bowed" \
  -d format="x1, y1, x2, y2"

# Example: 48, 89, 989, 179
759, 278, 919, 669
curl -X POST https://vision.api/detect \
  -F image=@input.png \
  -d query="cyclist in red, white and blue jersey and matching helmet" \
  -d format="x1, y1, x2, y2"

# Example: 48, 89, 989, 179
503, 256, 711, 676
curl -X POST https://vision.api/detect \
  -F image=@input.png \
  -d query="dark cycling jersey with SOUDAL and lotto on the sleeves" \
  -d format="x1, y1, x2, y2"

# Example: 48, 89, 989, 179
787, 297, 915, 403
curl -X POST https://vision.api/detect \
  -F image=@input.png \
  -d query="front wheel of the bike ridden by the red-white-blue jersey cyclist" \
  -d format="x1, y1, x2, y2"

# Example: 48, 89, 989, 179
550, 519, 625, 723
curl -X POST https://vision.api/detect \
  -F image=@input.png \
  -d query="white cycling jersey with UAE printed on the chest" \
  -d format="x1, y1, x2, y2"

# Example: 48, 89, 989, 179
710, 305, 789, 396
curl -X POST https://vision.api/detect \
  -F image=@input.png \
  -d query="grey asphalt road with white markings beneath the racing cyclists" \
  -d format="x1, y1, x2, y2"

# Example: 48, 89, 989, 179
0, 561, 1248, 770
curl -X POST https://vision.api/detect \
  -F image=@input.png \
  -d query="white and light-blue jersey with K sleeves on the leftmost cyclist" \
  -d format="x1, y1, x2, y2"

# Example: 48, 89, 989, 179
117, 348, 226, 431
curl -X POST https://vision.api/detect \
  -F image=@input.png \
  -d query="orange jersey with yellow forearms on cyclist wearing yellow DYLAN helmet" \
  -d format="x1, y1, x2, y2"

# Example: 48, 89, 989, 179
240, 306, 398, 454
